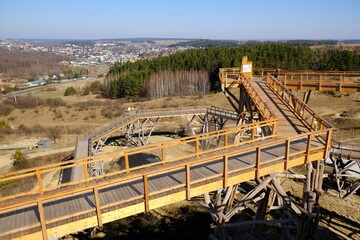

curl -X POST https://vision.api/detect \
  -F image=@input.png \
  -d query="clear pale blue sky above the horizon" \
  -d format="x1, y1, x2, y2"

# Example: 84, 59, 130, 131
0, 0, 360, 40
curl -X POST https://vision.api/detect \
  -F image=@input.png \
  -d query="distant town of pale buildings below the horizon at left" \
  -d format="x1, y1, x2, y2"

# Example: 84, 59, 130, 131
0, 39, 192, 67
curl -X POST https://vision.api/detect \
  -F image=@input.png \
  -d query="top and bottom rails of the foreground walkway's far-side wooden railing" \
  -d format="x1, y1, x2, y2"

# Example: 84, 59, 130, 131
0, 119, 277, 201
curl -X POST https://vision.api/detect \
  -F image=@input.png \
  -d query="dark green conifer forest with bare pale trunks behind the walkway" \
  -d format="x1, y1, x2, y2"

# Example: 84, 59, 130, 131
103, 43, 360, 98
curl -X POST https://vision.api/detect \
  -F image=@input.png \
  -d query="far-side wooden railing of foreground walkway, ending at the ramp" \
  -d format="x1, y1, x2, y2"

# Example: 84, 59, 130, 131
0, 119, 277, 202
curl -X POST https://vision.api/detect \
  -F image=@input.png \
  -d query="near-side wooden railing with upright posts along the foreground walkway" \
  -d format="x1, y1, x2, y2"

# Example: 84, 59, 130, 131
0, 129, 333, 234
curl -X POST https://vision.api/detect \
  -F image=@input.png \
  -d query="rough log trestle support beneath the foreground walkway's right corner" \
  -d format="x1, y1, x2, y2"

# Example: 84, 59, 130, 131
201, 161, 324, 240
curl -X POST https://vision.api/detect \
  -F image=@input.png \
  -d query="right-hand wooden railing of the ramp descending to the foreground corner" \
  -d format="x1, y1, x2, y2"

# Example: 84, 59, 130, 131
267, 75, 333, 131
